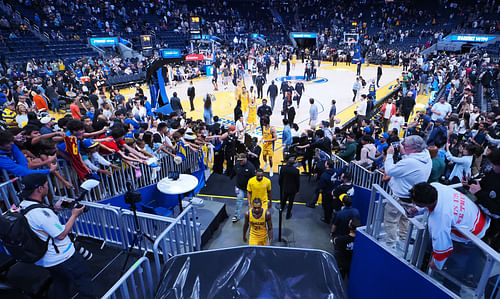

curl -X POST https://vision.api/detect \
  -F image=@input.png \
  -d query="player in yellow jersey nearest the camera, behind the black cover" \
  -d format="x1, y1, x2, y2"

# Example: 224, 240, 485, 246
243, 198, 273, 246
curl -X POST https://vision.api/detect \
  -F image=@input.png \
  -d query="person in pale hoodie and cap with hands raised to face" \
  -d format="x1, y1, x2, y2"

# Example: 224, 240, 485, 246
384, 135, 432, 248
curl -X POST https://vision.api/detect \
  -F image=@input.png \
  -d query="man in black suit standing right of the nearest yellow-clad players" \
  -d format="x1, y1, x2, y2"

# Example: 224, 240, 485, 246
279, 157, 300, 219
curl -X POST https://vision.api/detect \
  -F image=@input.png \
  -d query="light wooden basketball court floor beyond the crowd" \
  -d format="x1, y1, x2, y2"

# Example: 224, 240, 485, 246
132, 60, 401, 171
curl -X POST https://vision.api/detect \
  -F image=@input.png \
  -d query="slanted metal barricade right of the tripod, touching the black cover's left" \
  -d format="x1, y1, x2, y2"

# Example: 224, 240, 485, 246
153, 205, 201, 279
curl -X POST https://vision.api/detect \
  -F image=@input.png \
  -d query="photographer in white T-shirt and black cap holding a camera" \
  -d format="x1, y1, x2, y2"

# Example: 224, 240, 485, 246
20, 174, 96, 298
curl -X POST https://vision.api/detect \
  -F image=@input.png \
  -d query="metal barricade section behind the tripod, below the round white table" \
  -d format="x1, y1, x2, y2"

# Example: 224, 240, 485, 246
120, 209, 176, 252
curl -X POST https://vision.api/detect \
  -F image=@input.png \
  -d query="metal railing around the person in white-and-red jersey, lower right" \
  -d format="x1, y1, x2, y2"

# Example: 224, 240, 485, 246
365, 184, 500, 299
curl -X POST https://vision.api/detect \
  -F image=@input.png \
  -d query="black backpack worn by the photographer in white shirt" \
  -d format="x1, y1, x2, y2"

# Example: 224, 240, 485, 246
0, 204, 59, 263
